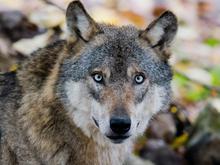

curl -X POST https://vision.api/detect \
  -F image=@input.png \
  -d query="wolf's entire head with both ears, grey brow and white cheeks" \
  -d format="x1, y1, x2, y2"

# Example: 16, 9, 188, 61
58, 1, 177, 143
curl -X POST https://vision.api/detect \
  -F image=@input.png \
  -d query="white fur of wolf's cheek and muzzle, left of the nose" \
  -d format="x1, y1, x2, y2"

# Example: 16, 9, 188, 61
65, 81, 109, 140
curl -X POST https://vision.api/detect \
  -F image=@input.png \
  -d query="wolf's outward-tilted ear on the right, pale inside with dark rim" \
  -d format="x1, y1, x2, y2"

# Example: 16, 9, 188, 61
140, 11, 178, 50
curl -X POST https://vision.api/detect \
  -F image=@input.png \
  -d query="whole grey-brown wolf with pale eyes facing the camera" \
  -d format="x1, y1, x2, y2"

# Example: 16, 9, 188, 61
0, 1, 177, 165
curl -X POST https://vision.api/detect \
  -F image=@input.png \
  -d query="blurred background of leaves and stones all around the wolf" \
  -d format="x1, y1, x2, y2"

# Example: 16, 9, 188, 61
0, 0, 220, 165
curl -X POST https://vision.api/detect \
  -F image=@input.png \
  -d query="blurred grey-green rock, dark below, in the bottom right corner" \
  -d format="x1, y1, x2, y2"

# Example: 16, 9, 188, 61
186, 102, 220, 165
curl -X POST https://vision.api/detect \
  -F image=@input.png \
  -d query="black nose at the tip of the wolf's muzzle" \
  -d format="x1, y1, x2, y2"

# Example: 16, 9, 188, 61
110, 117, 131, 134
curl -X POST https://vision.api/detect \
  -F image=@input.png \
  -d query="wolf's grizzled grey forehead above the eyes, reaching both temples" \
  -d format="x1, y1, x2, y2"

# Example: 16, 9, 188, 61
61, 25, 172, 85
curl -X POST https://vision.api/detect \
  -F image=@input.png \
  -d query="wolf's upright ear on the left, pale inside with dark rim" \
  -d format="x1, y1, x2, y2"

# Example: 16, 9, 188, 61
66, 1, 98, 41
